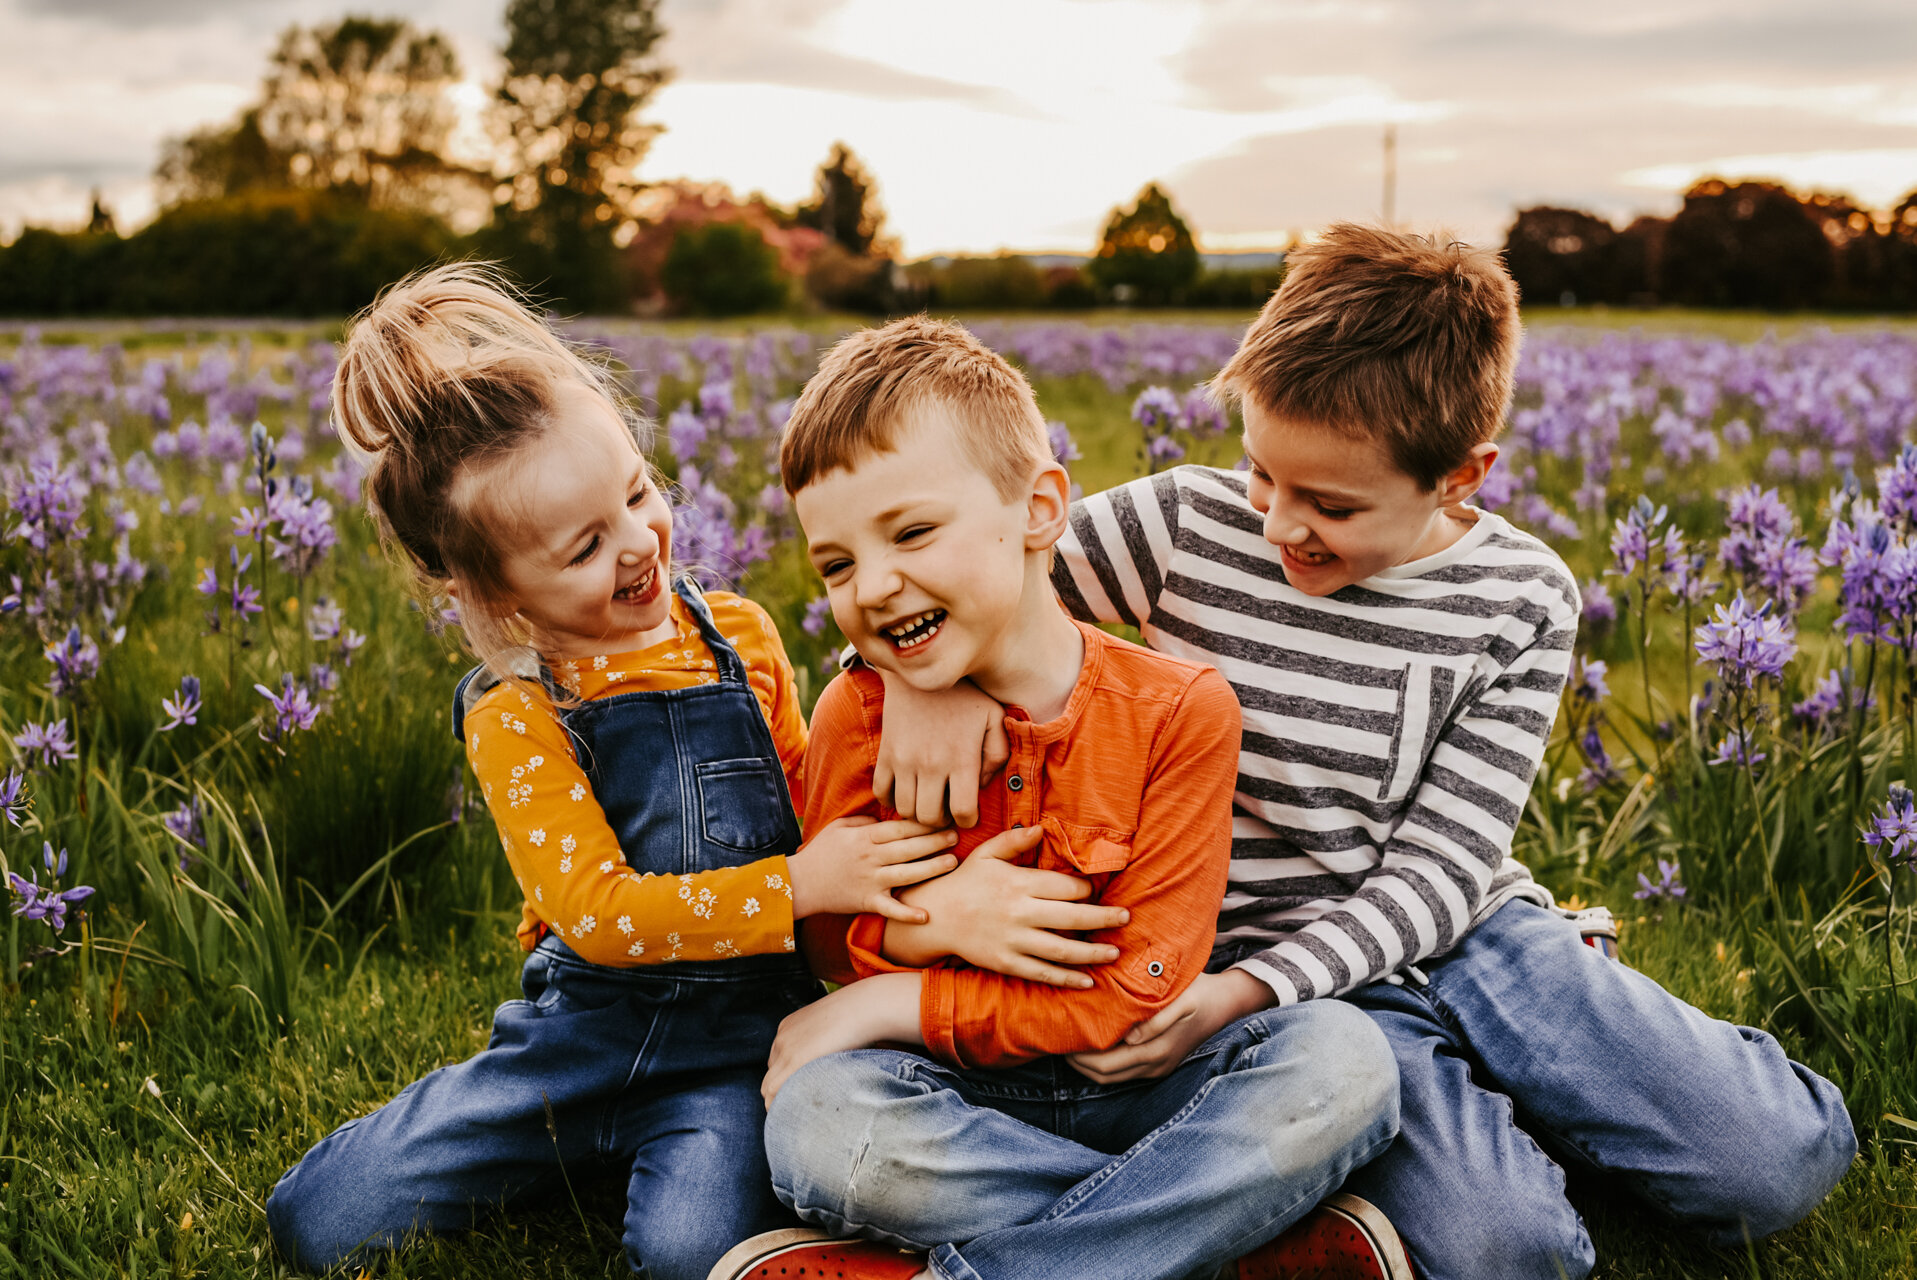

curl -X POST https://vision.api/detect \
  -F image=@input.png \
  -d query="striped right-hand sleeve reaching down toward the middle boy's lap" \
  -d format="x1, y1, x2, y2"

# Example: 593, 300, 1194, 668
1235, 615, 1576, 1004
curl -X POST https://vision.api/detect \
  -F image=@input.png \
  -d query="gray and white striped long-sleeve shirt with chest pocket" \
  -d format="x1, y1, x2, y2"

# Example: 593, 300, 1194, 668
1052, 466, 1578, 1004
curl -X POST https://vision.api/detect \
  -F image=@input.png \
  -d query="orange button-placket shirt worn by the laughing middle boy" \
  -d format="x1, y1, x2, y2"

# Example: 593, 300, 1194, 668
801, 623, 1238, 1067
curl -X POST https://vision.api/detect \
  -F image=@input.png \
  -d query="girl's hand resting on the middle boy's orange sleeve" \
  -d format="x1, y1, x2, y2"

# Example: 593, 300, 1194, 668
786, 816, 959, 924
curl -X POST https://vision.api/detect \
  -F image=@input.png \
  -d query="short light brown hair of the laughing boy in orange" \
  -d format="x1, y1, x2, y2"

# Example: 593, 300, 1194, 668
778, 316, 1051, 502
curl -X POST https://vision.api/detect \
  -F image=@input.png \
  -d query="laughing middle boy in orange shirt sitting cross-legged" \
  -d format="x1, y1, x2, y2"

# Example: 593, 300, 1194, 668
713, 318, 1396, 1280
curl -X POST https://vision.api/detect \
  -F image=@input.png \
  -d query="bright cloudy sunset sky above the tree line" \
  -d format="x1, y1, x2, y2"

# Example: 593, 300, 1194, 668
0, 0, 1917, 257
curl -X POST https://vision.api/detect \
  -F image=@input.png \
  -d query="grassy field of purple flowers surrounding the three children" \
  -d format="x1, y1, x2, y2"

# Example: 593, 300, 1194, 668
0, 322, 1917, 1276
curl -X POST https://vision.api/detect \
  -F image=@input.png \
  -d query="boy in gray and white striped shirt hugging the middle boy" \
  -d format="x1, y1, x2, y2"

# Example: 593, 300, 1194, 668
888, 226, 1856, 1280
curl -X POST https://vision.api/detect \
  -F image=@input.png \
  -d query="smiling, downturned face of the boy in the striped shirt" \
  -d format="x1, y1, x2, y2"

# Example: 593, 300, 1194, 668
1244, 397, 1497, 596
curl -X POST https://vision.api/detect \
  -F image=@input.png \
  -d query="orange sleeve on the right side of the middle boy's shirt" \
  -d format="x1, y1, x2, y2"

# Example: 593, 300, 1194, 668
920, 669, 1238, 1067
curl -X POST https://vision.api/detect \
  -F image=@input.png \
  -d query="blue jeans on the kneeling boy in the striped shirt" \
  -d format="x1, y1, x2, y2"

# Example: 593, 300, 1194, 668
1346, 901, 1858, 1280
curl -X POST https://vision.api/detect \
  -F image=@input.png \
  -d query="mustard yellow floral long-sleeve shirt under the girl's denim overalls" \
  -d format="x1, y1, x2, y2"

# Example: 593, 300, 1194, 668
466, 592, 805, 966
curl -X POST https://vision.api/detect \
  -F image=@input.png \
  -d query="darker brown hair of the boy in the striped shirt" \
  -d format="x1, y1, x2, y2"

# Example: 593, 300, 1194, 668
1213, 222, 1518, 489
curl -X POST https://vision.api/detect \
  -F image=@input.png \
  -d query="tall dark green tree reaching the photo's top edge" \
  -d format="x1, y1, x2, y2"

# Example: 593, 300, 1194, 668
487, 0, 669, 309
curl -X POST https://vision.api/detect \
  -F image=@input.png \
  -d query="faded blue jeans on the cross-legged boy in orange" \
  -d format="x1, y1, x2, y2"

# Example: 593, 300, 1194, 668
765, 1000, 1397, 1280
